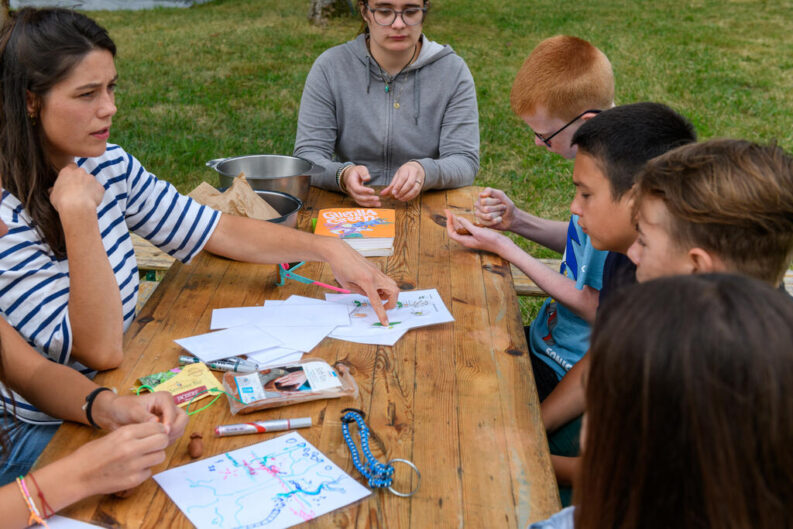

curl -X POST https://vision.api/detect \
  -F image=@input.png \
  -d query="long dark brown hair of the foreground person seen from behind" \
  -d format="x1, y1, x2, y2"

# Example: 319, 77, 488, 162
574, 274, 793, 529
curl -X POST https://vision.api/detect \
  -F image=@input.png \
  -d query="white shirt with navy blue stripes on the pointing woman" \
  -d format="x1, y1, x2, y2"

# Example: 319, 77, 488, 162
0, 144, 220, 423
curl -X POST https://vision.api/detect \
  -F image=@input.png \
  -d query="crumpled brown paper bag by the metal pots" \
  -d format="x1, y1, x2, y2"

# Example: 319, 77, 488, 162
188, 173, 281, 220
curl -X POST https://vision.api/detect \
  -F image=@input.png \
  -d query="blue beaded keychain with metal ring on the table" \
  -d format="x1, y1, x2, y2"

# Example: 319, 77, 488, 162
341, 408, 421, 498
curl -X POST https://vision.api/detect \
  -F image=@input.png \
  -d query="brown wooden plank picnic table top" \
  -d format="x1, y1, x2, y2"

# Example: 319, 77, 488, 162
39, 187, 560, 529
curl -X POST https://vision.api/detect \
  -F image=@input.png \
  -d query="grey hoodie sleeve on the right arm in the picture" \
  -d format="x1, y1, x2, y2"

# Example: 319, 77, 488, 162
416, 59, 479, 189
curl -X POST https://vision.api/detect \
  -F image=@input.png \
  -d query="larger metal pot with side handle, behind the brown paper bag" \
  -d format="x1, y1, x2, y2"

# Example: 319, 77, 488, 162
206, 154, 314, 203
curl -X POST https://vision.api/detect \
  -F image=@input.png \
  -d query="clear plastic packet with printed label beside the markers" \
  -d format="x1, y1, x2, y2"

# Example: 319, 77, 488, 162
223, 359, 358, 415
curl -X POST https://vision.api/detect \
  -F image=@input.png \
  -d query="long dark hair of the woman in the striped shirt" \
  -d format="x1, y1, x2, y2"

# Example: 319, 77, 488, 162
0, 8, 116, 259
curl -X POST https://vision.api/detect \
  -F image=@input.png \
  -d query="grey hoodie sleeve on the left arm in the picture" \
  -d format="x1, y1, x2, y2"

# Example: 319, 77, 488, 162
294, 59, 343, 191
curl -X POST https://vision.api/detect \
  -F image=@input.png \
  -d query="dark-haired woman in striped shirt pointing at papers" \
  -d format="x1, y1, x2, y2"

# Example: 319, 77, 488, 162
0, 8, 398, 480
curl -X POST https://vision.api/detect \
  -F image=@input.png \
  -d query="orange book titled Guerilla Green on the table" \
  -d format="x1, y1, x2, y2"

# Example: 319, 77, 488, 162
314, 208, 396, 256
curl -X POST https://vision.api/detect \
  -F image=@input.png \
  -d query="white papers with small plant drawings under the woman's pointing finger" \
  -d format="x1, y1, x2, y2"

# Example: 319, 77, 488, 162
325, 288, 454, 345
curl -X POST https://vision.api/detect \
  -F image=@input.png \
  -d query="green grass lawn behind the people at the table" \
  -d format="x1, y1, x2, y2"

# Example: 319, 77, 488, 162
89, 0, 793, 317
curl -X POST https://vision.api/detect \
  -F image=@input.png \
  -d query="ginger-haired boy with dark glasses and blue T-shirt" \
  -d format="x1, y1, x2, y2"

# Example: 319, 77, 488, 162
449, 35, 614, 400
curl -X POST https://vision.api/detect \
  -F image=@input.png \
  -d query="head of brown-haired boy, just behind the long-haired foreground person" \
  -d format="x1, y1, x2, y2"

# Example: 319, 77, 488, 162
628, 139, 793, 286
